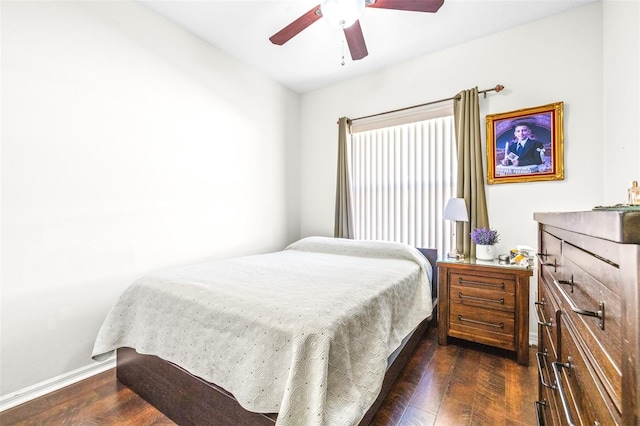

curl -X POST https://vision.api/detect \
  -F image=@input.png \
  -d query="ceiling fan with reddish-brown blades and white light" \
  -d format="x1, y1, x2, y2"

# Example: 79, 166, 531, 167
269, 0, 444, 61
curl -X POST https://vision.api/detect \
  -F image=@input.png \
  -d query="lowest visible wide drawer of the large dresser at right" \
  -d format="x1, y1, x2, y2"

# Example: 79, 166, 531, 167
552, 314, 621, 425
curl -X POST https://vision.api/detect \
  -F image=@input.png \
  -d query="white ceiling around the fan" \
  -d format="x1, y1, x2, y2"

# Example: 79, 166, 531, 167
139, 0, 595, 93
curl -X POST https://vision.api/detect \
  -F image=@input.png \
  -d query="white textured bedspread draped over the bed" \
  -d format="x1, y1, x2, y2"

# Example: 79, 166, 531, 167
93, 237, 432, 426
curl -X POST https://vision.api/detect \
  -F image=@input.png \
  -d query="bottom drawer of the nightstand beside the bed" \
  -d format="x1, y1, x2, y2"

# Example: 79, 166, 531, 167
449, 303, 515, 350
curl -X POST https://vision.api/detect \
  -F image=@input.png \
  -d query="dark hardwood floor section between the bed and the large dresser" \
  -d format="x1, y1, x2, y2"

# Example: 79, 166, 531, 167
373, 327, 538, 426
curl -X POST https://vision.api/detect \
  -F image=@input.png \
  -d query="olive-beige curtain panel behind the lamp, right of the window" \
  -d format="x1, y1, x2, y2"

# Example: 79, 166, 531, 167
453, 87, 489, 257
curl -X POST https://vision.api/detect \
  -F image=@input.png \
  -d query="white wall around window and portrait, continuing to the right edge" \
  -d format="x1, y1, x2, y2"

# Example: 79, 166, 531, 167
301, 1, 640, 342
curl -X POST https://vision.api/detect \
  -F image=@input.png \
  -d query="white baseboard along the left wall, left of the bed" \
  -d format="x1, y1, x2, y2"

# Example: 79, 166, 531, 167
0, 356, 116, 411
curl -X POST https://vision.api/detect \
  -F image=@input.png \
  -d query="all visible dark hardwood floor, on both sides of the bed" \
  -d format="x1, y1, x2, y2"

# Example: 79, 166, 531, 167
0, 326, 537, 426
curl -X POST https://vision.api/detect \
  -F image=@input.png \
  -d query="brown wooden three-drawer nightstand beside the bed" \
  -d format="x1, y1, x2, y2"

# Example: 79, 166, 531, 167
437, 259, 533, 365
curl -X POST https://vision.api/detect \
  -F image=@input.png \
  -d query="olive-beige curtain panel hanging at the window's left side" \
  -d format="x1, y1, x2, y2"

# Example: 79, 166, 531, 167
333, 117, 353, 239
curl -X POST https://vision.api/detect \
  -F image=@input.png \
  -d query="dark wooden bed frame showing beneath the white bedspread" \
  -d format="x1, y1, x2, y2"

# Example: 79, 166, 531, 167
116, 249, 438, 426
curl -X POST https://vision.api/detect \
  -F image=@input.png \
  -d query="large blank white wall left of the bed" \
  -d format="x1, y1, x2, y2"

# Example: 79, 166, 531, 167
0, 0, 299, 395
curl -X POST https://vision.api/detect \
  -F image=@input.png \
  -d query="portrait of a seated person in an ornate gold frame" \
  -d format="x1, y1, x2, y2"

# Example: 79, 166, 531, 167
487, 102, 564, 184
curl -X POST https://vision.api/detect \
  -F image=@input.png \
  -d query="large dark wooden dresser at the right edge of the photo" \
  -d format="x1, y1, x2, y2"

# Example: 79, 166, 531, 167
534, 210, 640, 426
